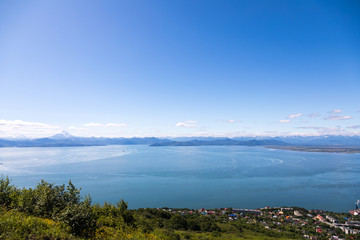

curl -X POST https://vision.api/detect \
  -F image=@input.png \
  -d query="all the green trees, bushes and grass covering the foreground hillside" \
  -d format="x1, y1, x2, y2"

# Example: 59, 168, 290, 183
0, 178, 360, 240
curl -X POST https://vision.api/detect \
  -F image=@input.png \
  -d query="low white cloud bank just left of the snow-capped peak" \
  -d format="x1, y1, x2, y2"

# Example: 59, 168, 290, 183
0, 120, 62, 138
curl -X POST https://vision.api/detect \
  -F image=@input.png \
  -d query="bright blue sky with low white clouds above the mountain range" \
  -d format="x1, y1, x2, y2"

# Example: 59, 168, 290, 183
0, 0, 360, 137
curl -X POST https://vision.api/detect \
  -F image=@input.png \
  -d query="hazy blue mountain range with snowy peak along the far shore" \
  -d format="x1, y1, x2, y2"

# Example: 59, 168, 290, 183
0, 134, 360, 149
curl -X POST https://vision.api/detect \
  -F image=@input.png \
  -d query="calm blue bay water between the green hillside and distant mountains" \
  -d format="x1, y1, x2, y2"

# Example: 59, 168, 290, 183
0, 145, 360, 211
